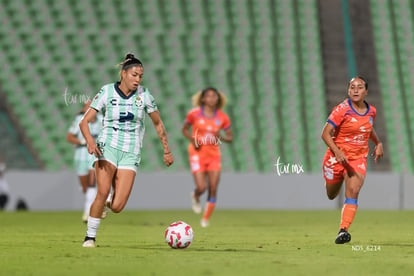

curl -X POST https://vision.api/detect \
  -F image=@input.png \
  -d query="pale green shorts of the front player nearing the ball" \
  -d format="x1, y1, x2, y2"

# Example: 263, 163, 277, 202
95, 143, 141, 172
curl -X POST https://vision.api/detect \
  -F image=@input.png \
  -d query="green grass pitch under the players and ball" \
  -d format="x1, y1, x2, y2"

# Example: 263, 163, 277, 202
0, 209, 414, 276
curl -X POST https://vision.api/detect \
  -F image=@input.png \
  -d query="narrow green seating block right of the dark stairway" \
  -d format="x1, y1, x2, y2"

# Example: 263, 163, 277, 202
370, 0, 414, 172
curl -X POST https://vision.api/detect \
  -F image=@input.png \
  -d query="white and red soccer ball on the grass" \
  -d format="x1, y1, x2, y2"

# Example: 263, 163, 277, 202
165, 221, 194, 249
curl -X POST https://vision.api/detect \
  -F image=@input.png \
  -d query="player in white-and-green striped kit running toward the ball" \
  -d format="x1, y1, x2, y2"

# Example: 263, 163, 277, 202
79, 54, 174, 247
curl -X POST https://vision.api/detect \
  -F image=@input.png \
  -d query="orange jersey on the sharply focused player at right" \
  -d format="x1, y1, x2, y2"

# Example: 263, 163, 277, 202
327, 99, 377, 160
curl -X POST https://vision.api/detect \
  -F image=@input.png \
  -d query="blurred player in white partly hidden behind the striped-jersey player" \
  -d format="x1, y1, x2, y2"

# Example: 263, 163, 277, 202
66, 101, 102, 223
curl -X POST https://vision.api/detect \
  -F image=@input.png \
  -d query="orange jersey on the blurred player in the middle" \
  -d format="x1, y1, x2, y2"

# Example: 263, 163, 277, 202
186, 107, 231, 156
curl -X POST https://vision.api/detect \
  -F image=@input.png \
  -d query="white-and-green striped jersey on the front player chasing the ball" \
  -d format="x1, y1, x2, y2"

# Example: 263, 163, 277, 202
91, 82, 157, 154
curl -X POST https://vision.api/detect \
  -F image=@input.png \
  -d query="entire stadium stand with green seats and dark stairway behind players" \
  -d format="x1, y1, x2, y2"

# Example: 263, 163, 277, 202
0, 0, 414, 173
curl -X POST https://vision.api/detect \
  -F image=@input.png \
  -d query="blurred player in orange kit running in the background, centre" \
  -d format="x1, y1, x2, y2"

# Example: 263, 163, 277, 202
182, 87, 233, 227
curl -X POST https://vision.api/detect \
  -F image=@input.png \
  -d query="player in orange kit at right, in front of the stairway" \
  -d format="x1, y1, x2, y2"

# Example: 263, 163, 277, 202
322, 76, 384, 244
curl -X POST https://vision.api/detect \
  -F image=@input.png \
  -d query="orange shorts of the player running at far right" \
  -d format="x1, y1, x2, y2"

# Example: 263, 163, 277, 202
322, 152, 367, 184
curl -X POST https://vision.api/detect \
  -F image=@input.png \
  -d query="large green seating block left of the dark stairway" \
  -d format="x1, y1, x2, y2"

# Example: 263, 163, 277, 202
0, 0, 326, 172
